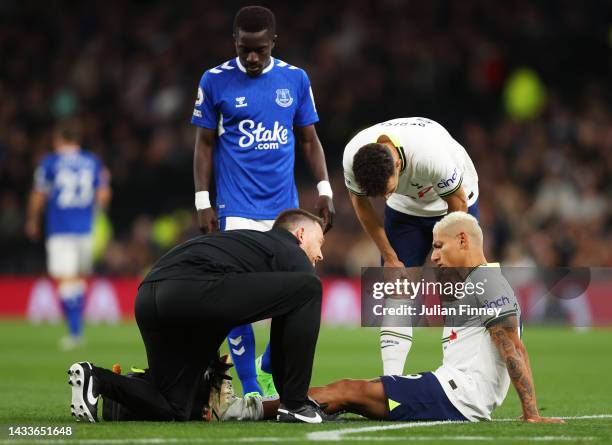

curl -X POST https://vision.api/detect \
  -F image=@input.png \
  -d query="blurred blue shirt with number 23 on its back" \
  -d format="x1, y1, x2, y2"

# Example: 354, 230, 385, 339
34, 150, 106, 237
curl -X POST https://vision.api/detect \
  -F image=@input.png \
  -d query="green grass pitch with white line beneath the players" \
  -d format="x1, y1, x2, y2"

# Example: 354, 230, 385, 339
0, 321, 612, 445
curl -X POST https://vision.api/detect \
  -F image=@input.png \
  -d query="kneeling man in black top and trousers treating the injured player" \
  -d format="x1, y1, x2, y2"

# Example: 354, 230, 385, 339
68, 209, 325, 423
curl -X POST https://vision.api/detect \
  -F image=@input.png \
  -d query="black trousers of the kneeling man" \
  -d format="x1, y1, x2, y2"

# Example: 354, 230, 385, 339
94, 272, 322, 420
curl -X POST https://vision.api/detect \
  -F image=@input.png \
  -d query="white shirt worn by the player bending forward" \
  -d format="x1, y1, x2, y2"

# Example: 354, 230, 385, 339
342, 117, 478, 216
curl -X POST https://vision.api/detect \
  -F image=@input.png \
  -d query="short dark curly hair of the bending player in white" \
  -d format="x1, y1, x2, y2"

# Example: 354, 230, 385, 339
353, 143, 394, 196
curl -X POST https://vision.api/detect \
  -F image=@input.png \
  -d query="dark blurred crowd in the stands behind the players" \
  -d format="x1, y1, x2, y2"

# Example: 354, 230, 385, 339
0, 0, 612, 275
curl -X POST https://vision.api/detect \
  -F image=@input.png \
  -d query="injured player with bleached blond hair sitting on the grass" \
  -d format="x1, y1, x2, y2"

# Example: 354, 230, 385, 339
213, 212, 563, 423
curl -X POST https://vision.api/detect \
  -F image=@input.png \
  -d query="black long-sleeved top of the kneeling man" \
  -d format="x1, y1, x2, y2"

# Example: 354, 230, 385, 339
142, 228, 314, 283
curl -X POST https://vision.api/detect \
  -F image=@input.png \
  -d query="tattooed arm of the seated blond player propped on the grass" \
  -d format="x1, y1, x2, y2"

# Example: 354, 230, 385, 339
488, 315, 563, 423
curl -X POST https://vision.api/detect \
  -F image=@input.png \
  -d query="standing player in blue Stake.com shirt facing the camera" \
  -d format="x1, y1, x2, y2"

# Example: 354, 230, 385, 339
191, 6, 334, 396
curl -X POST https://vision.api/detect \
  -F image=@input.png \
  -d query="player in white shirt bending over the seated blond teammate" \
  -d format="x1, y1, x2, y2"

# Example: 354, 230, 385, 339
342, 117, 479, 375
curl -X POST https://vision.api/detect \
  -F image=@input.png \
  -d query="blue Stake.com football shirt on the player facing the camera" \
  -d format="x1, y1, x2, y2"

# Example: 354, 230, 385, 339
191, 58, 319, 219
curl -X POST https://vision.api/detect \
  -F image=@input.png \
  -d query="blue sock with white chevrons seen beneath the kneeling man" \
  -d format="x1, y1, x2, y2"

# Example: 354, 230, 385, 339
227, 324, 262, 394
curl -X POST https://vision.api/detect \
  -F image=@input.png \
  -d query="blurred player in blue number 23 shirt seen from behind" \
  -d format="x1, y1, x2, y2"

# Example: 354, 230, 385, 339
25, 120, 111, 349
